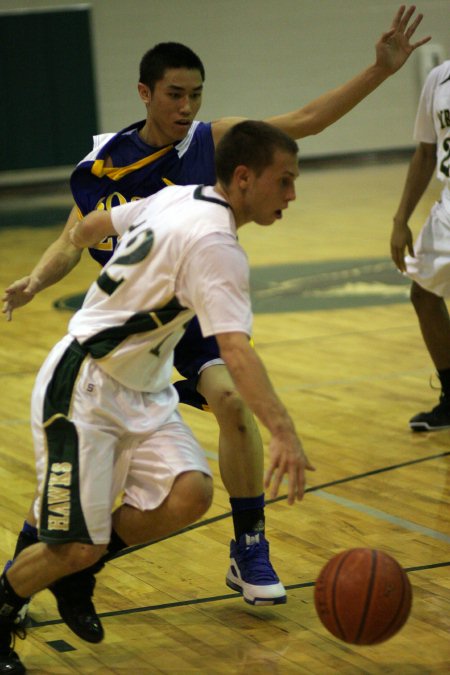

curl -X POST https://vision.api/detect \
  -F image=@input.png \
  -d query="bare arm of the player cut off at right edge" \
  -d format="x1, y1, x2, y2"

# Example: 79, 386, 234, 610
391, 143, 436, 272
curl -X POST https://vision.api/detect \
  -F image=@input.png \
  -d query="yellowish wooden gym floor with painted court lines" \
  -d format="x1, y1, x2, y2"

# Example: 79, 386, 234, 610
0, 157, 450, 675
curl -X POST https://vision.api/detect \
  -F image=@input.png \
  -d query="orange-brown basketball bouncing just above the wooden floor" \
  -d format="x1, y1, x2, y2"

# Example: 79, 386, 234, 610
314, 548, 412, 645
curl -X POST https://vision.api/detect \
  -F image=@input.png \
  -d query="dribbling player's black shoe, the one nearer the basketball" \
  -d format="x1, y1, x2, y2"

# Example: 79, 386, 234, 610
49, 570, 105, 644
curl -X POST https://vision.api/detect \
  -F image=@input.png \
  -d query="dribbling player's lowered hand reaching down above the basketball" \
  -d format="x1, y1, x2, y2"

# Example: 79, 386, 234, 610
264, 433, 315, 504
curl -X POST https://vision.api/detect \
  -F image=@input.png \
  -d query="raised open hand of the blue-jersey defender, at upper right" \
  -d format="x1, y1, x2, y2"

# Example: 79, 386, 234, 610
376, 5, 431, 74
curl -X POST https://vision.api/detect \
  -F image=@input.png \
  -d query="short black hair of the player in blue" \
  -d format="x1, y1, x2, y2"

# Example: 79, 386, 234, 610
139, 42, 205, 91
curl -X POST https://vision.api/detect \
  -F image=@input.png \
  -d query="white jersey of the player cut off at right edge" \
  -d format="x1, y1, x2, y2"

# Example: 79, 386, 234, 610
414, 61, 450, 214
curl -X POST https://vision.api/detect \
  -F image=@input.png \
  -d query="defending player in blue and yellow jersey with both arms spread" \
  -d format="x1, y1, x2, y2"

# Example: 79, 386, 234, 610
0, 1, 430, 648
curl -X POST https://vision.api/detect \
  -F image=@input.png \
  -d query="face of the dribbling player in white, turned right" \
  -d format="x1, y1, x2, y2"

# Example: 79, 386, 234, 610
245, 150, 298, 225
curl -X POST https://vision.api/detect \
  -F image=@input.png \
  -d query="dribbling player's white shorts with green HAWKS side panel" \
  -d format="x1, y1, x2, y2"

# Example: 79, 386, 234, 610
31, 336, 211, 544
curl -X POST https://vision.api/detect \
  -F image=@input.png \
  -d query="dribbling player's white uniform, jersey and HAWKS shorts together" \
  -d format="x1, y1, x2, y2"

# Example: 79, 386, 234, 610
32, 186, 252, 544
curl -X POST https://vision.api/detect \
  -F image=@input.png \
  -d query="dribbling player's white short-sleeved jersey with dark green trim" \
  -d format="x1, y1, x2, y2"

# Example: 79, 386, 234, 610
69, 185, 252, 393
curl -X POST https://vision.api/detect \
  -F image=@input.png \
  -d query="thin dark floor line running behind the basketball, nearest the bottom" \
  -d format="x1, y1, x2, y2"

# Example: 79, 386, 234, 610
30, 561, 450, 628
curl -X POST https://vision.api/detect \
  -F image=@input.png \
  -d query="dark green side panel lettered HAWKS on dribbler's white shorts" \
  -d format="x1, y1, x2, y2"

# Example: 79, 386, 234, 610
39, 342, 92, 544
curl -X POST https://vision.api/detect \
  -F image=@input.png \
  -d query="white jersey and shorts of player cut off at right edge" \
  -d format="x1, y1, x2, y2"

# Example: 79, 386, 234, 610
405, 61, 450, 298
